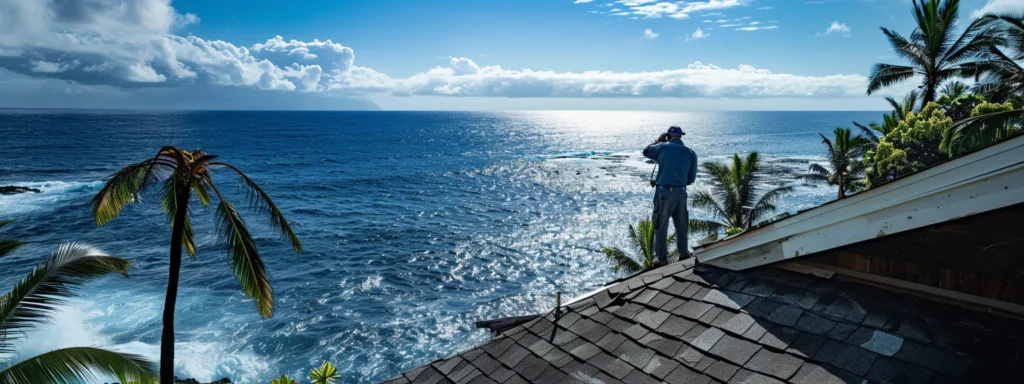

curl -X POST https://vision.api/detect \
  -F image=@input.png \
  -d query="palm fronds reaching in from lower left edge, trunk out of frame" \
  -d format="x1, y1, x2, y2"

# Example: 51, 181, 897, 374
0, 220, 156, 384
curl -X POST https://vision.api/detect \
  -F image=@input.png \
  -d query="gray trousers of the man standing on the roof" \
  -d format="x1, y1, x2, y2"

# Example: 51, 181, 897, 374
650, 186, 690, 262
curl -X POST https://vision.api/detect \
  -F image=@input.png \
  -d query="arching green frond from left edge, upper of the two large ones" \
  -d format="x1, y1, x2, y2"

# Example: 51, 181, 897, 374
0, 243, 129, 352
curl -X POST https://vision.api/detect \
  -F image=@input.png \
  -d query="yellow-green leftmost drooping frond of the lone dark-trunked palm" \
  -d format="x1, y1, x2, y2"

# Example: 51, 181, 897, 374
91, 160, 161, 225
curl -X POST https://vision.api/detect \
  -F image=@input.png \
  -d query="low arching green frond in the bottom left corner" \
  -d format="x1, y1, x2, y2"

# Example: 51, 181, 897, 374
0, 347, 157, 384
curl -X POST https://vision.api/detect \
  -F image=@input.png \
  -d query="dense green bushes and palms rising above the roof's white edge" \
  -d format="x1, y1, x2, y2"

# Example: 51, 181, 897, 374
854, 0, 1024, 191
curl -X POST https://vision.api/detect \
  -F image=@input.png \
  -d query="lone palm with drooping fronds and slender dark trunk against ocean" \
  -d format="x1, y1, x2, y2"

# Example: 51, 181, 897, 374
92, 146, 302, 383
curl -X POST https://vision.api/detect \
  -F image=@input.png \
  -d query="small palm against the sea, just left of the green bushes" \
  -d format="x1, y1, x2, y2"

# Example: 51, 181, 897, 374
804, 128, 870, 199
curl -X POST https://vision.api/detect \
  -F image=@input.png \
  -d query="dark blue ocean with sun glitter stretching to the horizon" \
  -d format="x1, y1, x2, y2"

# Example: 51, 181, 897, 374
0, 110, 881, 383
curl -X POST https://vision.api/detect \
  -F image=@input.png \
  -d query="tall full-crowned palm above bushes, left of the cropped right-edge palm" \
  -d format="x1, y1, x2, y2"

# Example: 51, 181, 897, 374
867, 0, 1002, 105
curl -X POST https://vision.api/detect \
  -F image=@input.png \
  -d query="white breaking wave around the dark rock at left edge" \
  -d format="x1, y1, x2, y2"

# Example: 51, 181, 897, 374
0, 180, 103, 218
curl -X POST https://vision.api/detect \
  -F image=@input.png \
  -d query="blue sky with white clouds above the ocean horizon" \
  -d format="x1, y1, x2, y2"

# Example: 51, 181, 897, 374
0, 0, 1024, 111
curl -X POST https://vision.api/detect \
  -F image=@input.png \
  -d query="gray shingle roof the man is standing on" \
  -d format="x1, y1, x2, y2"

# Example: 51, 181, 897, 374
389, 261, 1024, 383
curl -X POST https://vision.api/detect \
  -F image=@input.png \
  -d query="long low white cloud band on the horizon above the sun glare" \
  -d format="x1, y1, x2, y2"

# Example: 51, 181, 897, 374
394, 58, 866, 97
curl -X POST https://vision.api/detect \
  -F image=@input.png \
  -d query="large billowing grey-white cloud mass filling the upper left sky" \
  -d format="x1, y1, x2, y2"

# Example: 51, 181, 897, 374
0, 0, 392, 92
